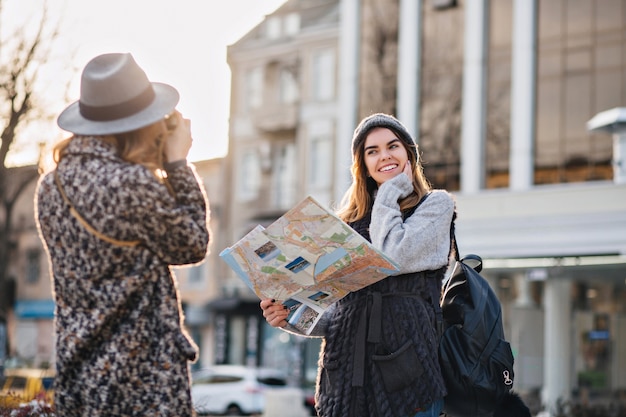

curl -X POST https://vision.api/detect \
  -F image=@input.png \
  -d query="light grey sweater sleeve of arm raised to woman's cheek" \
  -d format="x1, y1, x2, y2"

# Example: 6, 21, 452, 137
370, 175, 454, 274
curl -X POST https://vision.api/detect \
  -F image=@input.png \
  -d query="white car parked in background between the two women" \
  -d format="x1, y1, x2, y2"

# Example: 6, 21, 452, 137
191, 365, 287, 416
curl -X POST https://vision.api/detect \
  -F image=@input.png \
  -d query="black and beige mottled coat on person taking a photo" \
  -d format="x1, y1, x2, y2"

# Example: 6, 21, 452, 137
35, 137, 209, 417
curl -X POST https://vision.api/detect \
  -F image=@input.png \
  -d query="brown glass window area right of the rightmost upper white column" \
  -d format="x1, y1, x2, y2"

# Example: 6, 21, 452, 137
535, 0, 626, 184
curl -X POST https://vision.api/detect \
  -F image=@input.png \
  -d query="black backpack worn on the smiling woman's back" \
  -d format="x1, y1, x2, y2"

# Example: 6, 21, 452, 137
439, 224, 530, 417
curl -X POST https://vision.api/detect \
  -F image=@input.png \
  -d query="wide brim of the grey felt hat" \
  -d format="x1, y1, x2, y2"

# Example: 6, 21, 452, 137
57, 82, 180, 136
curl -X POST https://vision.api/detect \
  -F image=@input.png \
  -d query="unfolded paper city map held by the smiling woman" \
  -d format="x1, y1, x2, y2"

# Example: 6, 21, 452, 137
220, 197, 398, 334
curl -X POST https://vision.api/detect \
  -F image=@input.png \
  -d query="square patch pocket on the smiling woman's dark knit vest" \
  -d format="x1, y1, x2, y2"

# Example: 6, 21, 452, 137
372, 340, 424, 392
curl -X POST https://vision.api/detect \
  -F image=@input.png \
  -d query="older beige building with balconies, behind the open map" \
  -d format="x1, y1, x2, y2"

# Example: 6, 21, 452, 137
223, 0, 347, 384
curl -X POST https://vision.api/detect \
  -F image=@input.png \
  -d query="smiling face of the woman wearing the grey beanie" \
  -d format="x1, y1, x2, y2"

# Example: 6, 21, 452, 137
363, 127, 409, 185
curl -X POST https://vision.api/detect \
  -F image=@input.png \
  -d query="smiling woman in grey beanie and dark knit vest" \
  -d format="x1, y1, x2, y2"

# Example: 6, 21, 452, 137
260, 113, 455, 417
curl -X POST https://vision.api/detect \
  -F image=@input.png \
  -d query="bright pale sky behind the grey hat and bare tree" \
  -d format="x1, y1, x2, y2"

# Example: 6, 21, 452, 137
0, 0, 285, 164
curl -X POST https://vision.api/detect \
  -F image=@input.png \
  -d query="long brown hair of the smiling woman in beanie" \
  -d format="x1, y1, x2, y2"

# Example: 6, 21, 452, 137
337, 129, 432, 222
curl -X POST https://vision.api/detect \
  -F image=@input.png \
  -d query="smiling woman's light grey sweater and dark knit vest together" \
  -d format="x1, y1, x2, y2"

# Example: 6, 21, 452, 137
286, 175, 455, 417
